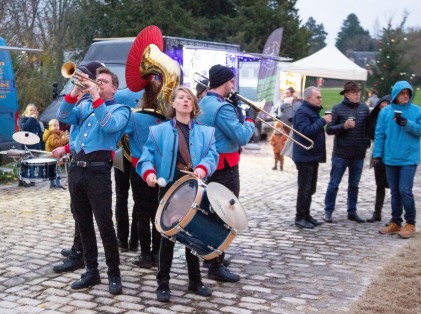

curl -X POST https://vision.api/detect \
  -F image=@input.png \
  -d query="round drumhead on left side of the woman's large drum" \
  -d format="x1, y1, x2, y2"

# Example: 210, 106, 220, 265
159, 178, 198, 231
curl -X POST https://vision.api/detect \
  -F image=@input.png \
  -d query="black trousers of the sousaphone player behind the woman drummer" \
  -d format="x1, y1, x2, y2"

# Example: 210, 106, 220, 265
130, 166, 161, 254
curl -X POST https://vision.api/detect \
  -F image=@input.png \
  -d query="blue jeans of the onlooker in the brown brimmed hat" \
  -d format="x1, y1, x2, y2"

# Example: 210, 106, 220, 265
325, 156, 364, 215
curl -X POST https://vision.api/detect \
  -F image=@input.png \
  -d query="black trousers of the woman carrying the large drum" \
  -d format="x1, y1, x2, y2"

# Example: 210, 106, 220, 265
156, 170, 202, 286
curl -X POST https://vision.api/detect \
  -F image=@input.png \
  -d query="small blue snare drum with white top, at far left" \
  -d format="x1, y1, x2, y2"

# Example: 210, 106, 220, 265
20, 158, 57, 181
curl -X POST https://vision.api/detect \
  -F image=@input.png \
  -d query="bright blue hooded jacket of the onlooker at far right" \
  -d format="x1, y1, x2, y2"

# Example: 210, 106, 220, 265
373, 81, 421, 166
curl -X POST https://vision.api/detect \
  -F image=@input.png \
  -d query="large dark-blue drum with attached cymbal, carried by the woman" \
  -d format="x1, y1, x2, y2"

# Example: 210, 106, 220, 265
155, 175, 247, 260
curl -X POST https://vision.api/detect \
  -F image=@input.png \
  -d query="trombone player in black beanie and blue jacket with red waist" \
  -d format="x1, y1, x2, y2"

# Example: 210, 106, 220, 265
197, 64, 257, 282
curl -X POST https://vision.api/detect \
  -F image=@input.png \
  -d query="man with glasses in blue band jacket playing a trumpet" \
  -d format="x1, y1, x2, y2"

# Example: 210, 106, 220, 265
57, 68, 131, 294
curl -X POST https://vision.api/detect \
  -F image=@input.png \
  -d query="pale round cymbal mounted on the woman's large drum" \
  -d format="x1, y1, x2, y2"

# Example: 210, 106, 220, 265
207, 182, 248, 230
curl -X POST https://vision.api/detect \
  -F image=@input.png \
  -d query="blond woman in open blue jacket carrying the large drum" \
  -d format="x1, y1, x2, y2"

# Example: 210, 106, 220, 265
136, 87, 218, 302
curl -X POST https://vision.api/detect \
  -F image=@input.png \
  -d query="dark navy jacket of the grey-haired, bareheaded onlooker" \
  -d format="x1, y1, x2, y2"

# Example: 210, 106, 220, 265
290, 101, 326, 162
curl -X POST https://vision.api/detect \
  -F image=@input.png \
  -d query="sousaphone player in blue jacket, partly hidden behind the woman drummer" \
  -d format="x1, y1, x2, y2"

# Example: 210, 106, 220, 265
126, 80, 167, 269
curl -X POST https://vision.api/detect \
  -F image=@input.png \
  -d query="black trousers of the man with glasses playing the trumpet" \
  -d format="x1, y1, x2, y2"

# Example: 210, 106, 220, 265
69, 165, 120, 275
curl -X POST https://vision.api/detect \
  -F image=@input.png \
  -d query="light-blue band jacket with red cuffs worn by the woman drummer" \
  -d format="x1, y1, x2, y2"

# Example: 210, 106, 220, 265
136, 119, 218, 183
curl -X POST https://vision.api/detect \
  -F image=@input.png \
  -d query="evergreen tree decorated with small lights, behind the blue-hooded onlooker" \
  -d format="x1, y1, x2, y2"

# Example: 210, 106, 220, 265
373, 16, 415, 95
